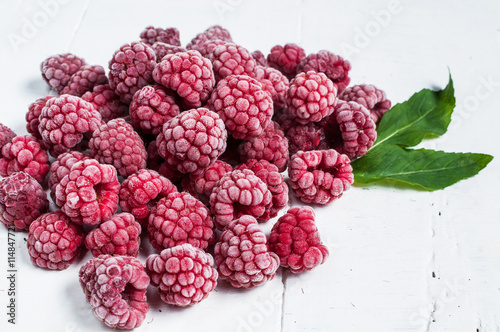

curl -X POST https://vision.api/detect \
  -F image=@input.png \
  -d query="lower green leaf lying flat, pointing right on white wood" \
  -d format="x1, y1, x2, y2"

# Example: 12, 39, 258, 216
351, 144, 493, 191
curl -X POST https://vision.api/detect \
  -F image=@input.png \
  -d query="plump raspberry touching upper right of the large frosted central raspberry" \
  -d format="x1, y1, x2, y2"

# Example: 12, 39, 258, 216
209, 75, 273, 140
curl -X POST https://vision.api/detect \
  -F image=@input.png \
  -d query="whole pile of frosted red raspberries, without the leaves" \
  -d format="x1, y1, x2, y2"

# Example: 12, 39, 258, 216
0, 26, 391, 329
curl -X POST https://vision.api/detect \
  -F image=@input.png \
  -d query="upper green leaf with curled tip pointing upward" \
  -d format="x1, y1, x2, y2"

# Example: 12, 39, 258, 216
372, 75, 455, 149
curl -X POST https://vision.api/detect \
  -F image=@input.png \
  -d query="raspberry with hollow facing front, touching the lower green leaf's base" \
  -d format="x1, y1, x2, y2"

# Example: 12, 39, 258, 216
288, 149, 354, 204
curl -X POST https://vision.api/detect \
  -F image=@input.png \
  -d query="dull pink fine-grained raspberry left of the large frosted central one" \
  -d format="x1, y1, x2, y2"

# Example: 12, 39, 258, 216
89, 118, 148, 177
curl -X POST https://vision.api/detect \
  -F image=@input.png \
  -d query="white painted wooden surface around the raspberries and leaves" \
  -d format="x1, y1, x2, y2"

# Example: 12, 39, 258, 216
0, 0, 500, 332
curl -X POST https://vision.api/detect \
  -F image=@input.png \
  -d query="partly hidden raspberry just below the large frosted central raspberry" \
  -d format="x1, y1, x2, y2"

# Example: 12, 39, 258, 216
182, 160, 233, 206
